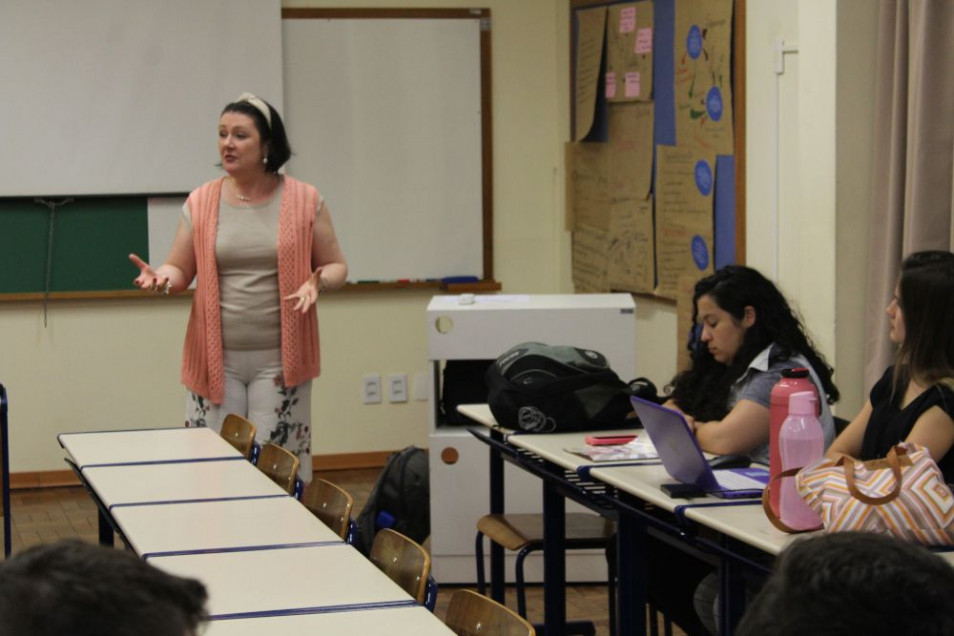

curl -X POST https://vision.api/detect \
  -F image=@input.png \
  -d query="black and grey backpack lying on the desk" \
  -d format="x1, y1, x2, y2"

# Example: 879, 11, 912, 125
484, 342, 637, 433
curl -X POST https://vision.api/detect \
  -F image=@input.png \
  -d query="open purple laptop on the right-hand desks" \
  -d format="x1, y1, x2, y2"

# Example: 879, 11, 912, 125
630, 397, 769, 498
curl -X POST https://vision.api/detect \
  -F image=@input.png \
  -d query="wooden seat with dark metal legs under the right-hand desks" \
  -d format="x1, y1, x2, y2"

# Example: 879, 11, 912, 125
474, 512, 616, 635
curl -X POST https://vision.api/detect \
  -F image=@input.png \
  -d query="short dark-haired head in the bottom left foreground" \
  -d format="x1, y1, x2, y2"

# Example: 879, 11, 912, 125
0, 539, 208, 636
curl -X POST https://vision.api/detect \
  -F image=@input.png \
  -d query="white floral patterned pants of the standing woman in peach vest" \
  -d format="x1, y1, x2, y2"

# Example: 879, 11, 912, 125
185, 349, 312, 484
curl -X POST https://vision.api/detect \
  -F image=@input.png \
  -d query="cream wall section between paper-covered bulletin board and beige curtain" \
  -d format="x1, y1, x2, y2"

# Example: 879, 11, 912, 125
746, 0, 878, 418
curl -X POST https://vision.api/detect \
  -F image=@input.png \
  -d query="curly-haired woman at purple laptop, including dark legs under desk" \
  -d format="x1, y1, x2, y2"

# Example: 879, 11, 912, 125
649, 265, 839, 636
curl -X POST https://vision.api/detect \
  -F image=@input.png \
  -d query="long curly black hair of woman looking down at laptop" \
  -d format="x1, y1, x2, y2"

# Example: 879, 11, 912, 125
667, 265, 840, 421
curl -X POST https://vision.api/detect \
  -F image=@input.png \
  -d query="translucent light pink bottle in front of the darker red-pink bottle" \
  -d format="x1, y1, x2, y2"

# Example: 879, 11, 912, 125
778, 391, 825, 530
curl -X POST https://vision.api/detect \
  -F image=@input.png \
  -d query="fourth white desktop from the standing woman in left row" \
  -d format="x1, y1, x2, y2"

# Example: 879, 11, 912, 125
147, 543, 412, 616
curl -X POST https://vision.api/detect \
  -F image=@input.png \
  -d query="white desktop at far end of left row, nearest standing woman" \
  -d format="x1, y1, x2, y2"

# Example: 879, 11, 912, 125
57, 426, 242, 468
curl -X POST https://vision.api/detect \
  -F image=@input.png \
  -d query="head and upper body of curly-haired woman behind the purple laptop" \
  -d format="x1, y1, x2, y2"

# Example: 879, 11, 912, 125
667, 265, 840, 464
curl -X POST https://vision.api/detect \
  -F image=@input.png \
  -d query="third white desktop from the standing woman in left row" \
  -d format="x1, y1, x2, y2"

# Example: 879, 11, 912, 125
112, 495, 341, 556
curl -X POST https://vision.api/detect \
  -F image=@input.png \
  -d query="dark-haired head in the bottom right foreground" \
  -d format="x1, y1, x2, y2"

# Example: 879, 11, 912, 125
736, 532, 954, 636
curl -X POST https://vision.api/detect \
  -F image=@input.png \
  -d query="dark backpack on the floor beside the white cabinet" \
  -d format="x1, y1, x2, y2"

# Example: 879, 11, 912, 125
355, 446, 431, 555
